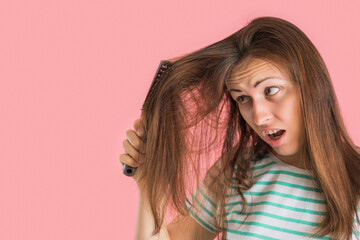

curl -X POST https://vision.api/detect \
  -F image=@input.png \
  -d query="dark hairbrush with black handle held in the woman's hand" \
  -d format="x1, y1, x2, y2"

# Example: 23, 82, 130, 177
122, 60, 172, 176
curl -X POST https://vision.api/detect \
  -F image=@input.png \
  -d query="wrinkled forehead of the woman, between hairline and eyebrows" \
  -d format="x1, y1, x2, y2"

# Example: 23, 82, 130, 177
226, 58, 287, 85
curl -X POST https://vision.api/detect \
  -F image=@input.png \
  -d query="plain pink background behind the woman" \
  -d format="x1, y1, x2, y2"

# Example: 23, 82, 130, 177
0, 0, 360, 240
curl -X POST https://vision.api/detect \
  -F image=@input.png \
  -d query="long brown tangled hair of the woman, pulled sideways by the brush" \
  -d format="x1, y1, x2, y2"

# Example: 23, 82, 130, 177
139, 17, 360, 239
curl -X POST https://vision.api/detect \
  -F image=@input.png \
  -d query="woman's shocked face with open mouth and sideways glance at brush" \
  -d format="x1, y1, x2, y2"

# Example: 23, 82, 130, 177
226, 59, 304, 168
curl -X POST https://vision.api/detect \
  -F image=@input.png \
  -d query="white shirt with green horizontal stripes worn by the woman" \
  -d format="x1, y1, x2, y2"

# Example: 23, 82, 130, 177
186, 152, 360, 240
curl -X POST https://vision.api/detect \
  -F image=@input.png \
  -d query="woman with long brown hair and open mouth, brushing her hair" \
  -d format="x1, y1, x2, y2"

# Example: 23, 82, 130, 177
120, 17, 360, 240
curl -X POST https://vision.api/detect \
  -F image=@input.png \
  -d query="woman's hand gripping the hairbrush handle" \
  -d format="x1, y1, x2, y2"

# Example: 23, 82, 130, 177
120, 119, 146, 181
